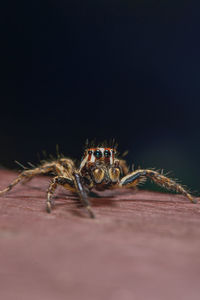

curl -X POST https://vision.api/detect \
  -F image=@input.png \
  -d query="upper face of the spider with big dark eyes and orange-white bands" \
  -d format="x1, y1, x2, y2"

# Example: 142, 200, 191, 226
80, 147, 116, 169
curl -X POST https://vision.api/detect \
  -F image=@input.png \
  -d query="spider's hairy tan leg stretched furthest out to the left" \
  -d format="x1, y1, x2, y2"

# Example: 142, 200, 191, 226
0, 159, 73, 195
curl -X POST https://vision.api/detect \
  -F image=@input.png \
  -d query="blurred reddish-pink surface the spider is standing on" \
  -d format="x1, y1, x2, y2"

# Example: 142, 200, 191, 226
0, 170, 200, 300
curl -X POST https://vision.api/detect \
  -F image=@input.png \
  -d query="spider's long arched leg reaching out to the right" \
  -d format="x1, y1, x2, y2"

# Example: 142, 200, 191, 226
119, 169, 197, 203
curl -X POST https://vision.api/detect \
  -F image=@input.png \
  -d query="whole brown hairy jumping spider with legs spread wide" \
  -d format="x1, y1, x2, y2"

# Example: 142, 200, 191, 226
0, 144, 196, 218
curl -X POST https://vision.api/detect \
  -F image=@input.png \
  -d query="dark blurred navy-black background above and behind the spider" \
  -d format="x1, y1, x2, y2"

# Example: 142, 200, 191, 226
0, 0, 200, 190
